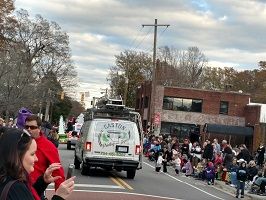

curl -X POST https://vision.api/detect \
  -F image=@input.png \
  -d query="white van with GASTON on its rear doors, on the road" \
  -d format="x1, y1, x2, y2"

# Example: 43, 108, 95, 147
74, 105, 142, 179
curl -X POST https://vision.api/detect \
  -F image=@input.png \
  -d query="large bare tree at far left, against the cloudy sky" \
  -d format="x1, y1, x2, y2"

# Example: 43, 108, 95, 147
0, 10, 77, 118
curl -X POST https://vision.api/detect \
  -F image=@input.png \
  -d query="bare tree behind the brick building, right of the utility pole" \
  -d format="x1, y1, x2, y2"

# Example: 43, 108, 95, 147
158, 46, 207, 88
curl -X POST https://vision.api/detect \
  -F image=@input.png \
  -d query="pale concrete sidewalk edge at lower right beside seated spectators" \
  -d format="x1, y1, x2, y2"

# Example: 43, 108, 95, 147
214, 180, 266, 200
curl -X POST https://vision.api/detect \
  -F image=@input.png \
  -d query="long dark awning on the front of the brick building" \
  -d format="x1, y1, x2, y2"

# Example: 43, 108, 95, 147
203, 124, 253, 136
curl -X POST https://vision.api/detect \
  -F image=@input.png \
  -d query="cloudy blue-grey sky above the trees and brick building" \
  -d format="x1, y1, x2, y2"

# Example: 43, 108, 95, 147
15, 0, 266, 107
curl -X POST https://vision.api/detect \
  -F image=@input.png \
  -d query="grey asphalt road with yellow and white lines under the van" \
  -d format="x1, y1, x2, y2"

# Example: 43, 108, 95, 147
47, 144, 241, 200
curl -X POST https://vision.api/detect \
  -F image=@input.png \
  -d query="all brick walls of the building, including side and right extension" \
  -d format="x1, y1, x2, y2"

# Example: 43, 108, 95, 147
137, 82, 266, 151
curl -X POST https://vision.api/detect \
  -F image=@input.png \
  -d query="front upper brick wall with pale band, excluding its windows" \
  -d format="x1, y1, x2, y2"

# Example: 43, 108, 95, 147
155, 86, 249, 137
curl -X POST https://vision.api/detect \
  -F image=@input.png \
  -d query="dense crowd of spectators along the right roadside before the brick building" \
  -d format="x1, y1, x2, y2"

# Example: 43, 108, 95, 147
143, 135, 266, 198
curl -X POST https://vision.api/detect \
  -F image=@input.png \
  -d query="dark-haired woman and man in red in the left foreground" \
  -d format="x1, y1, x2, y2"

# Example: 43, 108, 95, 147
0, 115, 75, 200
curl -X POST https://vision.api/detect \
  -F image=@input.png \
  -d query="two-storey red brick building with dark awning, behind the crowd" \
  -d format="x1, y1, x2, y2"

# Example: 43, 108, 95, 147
136, 82, 265, 151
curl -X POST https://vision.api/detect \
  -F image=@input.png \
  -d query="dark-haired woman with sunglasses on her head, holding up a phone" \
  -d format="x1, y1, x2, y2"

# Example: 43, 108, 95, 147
0, 128, 75, 200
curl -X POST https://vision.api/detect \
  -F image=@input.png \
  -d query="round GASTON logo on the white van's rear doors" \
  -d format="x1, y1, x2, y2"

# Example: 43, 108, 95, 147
97, 123, 132, 147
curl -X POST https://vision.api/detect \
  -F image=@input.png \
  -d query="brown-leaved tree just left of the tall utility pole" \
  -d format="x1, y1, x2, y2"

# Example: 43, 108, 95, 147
107, 50, 152, 107
